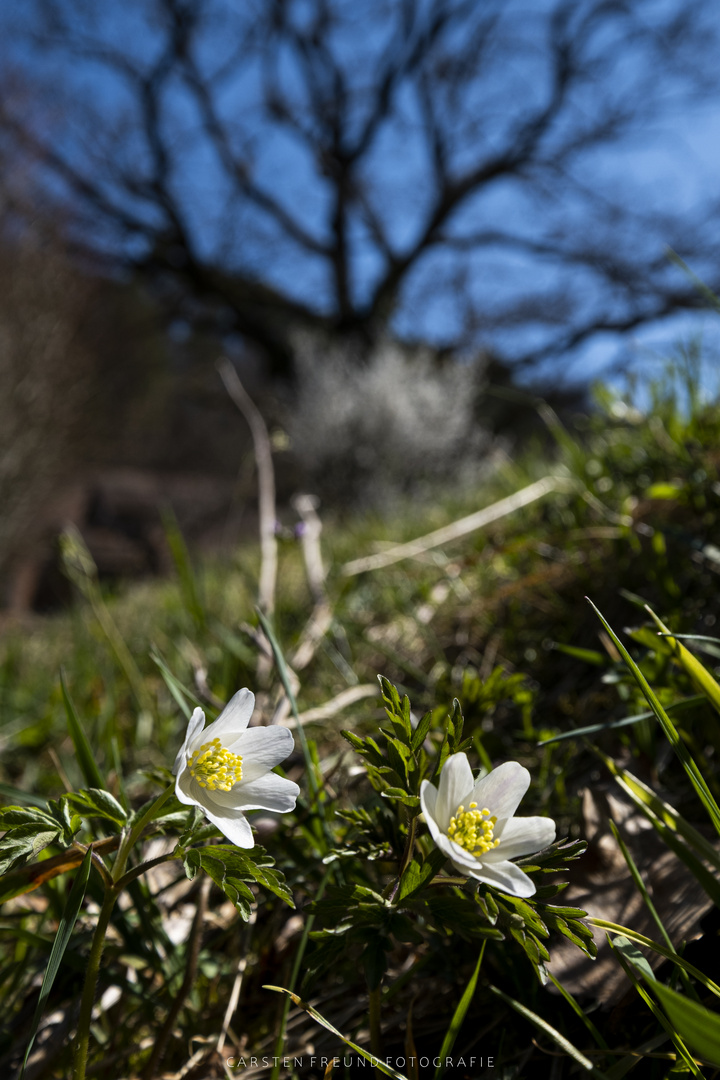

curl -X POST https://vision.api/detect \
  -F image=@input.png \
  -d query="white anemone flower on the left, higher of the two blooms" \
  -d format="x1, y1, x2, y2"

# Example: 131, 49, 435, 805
173, 689, 300, 848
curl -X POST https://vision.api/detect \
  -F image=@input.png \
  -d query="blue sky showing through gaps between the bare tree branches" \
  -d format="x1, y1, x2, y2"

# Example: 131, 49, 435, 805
0, 0, 720, 393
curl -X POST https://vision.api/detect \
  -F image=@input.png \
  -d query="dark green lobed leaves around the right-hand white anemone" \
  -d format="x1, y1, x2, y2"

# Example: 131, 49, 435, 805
313, 676, 596, 988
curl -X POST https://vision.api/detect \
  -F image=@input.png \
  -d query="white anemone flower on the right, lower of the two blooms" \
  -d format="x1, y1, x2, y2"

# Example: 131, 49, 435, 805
420, 754, 555, 896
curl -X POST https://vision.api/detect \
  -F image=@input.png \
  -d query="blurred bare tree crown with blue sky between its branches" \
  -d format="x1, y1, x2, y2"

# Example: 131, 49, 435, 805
0, 0, 720, 373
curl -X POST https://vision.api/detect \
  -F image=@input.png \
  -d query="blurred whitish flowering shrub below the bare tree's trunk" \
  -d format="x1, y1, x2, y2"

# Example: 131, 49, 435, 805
287, 337, 491, 503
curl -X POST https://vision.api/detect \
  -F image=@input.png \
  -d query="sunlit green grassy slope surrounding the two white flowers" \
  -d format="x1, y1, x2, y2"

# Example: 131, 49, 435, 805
0, 354, 720, 1080
